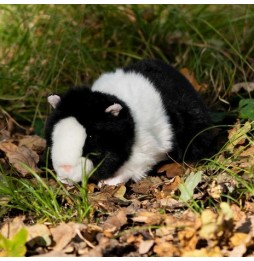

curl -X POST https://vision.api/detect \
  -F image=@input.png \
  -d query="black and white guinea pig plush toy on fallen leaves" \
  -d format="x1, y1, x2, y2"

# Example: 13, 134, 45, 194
45, 60, 211, 185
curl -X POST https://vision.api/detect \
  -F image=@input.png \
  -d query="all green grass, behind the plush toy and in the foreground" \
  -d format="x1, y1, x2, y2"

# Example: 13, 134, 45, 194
0, 5, 254, 221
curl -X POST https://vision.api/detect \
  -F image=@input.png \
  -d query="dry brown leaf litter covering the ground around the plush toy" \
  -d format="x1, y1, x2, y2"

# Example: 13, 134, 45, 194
0, 117, 254, 257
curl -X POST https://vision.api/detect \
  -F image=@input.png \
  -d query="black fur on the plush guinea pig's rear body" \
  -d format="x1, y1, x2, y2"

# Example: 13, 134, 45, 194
124, 60, 213, 161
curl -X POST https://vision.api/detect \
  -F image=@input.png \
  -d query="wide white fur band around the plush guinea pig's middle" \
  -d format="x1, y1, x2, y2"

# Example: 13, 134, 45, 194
92, 69, 173, 185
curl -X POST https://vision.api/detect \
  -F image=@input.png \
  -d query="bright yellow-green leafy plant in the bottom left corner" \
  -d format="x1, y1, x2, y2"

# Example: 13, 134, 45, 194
0, 225, 28, 257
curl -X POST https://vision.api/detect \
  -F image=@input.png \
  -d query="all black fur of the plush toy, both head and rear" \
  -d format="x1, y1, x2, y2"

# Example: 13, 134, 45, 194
45, 60, 212, 180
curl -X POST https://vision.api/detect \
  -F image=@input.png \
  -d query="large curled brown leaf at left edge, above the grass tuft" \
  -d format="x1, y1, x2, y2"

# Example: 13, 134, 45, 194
0, 142, 39, 177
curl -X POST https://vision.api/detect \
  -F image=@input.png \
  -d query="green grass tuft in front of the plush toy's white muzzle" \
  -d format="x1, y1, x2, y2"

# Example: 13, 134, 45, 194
0, 166, 90, 223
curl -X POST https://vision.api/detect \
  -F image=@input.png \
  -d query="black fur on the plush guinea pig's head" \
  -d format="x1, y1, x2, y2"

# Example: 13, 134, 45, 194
45, 87, 134, 180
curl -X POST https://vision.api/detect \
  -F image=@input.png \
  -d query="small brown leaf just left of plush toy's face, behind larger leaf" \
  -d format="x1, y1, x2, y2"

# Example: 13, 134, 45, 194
19, 135, 46, 154
